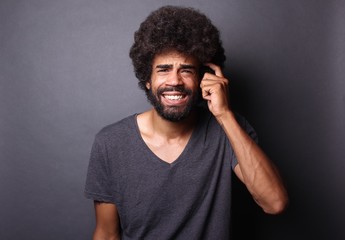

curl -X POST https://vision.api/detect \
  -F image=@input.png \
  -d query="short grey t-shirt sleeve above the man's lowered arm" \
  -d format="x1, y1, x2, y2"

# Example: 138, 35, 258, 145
84, 136, 113, 202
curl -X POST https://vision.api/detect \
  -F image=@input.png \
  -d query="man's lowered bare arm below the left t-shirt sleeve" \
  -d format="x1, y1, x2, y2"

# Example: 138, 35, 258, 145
93, 201, 121, 240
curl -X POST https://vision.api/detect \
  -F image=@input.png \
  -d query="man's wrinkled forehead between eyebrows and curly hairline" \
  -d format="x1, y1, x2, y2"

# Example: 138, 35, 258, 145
152, 51, 198, 66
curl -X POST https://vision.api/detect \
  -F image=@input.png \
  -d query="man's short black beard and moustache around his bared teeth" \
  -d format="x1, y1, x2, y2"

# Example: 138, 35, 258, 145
146, 87, 200, 122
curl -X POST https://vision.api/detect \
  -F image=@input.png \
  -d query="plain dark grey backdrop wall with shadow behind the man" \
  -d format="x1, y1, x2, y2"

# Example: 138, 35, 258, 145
0, 0, 345, 240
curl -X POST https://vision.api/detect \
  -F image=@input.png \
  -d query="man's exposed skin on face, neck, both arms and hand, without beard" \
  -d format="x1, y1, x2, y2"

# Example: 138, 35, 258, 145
93, 51, 288, 240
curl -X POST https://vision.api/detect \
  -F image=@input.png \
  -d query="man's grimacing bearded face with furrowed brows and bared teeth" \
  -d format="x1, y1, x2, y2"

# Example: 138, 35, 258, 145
146, 51, 200, 122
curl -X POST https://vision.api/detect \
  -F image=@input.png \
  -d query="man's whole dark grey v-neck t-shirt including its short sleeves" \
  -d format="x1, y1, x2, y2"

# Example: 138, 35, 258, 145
85, 110, 256, 240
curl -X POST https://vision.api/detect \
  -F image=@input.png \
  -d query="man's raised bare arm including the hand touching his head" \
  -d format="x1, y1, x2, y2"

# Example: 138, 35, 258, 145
200, 64, 288, 214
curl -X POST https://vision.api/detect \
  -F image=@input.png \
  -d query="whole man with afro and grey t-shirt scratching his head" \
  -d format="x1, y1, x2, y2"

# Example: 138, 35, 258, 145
85, 6, 288, 240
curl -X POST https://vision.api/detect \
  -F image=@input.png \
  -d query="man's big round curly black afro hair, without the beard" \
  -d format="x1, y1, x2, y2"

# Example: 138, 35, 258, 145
129, 6, 225, 91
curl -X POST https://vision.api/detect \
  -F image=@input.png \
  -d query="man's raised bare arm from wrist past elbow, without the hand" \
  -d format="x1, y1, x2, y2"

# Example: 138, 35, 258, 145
218, 112, 287, 214
